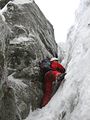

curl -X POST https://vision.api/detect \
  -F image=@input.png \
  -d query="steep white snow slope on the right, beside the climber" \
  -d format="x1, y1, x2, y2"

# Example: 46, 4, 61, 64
25, 0, 90, 120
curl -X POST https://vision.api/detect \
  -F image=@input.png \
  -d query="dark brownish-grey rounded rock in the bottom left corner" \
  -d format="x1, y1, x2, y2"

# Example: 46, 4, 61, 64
0, 84, 16, 120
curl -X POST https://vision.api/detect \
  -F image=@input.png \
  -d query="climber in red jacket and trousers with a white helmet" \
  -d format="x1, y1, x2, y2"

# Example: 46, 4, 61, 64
41, 57, 65, 107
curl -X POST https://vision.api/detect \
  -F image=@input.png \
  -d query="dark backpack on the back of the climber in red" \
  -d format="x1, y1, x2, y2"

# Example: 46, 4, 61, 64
39, 59, 51, 75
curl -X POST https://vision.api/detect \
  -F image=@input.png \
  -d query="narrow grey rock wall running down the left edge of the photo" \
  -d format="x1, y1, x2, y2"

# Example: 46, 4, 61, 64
0, 16, 18, 120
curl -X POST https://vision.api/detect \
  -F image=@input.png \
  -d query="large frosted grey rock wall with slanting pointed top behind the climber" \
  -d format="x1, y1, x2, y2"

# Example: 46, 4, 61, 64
0, 2, 57, 120
